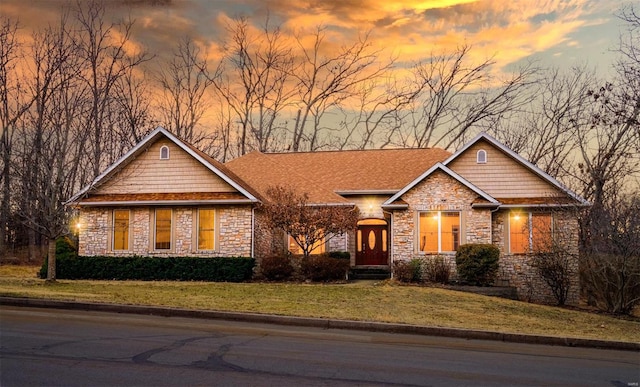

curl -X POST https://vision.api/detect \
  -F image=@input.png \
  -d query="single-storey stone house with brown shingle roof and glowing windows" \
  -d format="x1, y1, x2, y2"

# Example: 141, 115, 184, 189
69, 128, 588, 303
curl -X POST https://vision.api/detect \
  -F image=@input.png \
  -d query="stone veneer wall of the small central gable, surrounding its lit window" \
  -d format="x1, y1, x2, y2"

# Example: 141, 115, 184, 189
392, 172, 491, 261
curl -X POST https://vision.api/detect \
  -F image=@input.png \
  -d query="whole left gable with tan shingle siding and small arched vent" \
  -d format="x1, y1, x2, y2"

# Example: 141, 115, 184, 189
67, 128, 258, 205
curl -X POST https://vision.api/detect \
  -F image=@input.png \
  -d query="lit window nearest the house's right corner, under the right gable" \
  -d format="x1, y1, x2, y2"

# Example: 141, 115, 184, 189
509, 212, 553, 254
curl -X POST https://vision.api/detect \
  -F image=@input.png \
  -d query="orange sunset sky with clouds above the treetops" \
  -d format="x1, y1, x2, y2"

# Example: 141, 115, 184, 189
0, 0, 630, 77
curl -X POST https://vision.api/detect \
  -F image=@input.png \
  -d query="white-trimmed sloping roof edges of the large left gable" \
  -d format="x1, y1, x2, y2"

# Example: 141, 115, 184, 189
65, 127, 258, 204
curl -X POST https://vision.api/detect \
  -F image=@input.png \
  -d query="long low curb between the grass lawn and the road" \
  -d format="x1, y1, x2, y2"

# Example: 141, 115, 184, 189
0, 297, 640, 351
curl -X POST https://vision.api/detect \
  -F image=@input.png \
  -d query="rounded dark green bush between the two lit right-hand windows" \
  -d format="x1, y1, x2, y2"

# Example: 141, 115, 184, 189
456, 243, 500, 286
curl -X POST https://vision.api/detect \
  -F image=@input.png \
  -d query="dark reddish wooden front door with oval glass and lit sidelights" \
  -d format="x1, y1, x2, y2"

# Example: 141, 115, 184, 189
356, 225, 389, 265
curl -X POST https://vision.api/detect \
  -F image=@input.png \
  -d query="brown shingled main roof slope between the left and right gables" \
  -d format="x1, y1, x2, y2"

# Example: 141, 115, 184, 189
225, 148, 451, 204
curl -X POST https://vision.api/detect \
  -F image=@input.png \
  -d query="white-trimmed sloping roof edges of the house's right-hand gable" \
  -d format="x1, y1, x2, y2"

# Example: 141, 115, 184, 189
443, 132, 590, 206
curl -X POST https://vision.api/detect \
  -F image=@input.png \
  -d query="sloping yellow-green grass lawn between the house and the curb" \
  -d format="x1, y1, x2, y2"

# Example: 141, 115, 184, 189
0, 265, 640, 342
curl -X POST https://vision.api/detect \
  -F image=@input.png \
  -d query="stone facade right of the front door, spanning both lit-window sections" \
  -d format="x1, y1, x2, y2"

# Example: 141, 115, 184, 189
392, 172, 580, 305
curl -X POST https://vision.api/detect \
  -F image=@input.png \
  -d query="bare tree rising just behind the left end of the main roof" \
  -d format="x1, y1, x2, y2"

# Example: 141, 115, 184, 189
213, 18, 293, 155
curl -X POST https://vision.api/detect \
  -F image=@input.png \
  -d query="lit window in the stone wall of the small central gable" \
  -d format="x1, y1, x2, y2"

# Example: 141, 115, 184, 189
418, 211, 460, 253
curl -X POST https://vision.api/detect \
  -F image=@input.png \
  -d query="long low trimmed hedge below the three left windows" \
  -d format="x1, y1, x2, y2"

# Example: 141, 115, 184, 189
40, 255, 255, 282
